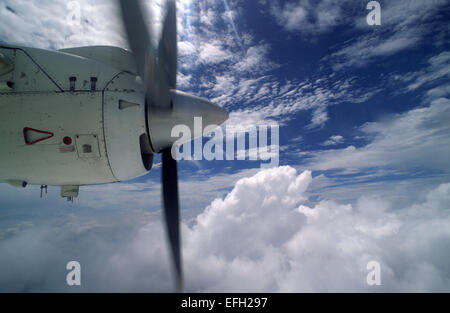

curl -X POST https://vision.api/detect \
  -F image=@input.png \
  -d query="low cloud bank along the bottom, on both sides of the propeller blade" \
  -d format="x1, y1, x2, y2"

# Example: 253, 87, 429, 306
0, 166, 450, 292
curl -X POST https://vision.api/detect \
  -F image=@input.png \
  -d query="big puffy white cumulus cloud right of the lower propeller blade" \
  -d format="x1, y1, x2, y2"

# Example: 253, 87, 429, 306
185, 167, 450, 292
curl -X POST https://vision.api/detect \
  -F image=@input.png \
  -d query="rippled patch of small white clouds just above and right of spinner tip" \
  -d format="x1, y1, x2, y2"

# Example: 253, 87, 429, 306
205, 72, 379, 129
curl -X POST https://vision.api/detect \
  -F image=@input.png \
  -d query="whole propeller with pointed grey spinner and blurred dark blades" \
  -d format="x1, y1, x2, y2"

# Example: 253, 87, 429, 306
119, 0, 228, 292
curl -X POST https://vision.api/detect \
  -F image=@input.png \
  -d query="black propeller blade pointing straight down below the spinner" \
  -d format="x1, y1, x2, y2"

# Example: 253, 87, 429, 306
162, 148, 183, 292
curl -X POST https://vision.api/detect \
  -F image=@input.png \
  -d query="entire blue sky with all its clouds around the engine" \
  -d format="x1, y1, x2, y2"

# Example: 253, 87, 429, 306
0, 0, 450, 292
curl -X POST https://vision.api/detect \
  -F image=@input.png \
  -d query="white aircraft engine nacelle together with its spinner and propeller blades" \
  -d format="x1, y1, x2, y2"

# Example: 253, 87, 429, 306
0, 0, 228, 291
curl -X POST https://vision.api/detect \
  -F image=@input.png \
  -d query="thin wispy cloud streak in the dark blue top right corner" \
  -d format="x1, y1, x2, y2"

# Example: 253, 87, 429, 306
324, 0, 446, 70
